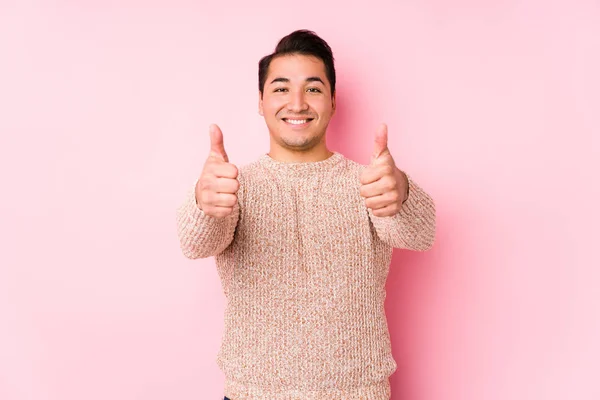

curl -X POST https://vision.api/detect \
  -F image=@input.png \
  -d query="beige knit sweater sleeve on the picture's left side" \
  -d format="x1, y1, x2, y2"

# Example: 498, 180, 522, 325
177, 184, 239, 259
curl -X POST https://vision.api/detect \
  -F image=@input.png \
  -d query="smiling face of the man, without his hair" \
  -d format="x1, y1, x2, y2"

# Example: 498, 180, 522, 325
258, 55, 335, 151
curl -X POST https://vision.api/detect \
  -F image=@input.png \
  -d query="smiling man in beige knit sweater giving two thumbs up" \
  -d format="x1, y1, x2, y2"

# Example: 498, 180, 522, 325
178, 30, 435, 400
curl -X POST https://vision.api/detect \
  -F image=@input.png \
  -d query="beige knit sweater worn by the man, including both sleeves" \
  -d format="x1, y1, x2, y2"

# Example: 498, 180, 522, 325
178, 153, 435, 400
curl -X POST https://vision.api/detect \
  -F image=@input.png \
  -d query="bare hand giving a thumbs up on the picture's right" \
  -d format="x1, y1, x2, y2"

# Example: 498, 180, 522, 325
360, 124, 408, 217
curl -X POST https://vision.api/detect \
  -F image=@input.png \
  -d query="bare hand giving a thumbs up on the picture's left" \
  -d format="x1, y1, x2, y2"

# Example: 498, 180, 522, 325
196, 125, 240, 218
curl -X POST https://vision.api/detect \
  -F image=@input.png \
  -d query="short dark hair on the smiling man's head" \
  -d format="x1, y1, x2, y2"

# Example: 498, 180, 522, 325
258, 29, 335, 96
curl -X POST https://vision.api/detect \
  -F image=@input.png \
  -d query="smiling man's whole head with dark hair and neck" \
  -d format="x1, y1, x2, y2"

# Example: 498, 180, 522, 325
258, 30, 335, 159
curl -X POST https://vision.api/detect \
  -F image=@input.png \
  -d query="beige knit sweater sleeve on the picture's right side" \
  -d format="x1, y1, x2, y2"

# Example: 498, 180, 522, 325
369, 175, 436, 251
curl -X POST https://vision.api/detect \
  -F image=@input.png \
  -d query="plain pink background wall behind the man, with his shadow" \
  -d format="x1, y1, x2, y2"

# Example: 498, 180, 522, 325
0, 0, 600, 400
